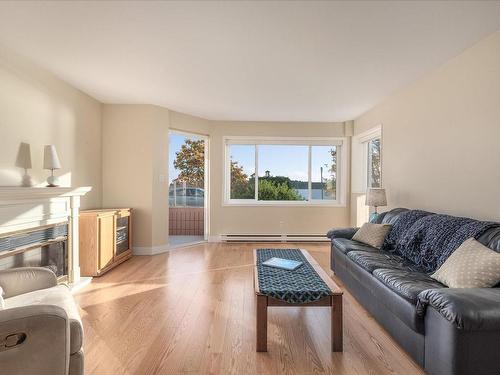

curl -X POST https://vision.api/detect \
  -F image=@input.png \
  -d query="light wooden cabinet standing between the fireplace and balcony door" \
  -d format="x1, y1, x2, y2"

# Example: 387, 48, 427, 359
80, 208, 132, 276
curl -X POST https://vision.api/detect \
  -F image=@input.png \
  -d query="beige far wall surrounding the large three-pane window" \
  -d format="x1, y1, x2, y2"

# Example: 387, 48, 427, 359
210, 121, 349, 236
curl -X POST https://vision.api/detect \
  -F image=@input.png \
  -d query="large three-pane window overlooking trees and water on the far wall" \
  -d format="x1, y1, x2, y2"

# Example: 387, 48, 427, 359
224, 138, 344, 205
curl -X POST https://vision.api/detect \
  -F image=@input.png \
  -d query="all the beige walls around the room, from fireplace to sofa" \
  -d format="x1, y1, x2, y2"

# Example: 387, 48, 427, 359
8, 24, 500, 249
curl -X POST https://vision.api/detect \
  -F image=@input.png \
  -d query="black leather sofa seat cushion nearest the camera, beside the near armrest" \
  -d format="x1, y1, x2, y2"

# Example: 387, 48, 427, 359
373, 268, 445, 305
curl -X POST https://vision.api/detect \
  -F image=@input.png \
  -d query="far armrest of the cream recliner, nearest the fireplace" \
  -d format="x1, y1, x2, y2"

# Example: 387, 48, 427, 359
0, 267, 57, 298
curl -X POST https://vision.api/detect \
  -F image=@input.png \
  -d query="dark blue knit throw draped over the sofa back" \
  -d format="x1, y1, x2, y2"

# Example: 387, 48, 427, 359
393, 214, 498, 272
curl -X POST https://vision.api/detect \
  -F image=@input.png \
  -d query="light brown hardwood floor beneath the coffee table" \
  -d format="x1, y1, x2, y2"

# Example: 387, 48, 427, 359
76, 243, 423, 375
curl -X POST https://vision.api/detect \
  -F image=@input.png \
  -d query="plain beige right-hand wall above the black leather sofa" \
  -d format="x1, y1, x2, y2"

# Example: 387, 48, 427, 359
353, 31, 500, 221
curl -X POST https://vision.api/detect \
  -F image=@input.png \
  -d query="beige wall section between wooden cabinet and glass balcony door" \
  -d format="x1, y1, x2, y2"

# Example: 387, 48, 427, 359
102, 104, 169, 251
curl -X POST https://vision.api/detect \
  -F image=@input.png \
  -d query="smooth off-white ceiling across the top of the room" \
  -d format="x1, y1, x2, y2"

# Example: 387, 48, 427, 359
0, 1, 500, 121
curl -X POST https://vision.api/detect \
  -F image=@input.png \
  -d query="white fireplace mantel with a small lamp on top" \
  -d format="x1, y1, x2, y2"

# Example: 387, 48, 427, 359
0, 186, 92, 283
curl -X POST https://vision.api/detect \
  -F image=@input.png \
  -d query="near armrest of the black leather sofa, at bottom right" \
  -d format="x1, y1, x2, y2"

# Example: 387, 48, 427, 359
417, 288, 500, 331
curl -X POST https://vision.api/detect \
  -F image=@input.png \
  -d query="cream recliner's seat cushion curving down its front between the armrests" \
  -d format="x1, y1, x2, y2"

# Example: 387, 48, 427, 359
5, 285, 83, 354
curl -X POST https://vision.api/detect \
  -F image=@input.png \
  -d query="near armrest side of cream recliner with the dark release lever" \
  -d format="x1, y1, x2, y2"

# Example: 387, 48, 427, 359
0, 305, 70, 374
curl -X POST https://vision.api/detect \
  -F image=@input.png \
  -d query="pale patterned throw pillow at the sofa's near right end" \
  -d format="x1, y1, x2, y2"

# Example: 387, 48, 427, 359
431, 238, 500, 288
